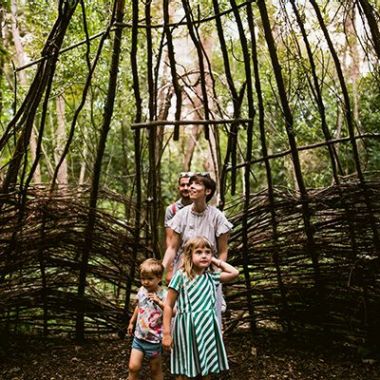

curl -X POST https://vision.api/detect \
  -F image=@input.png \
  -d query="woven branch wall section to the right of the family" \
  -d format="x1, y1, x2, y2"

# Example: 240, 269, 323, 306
228, 178, 380, 343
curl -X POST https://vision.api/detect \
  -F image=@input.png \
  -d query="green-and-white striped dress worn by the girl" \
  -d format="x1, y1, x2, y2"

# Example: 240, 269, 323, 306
169, 270, 228, 377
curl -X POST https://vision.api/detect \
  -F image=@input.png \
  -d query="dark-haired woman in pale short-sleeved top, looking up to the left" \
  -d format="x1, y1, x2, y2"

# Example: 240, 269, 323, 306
162, 174, 232, 320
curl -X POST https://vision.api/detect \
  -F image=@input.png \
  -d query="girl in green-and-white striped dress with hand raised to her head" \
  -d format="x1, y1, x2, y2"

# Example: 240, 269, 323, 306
162, 237, 239, 379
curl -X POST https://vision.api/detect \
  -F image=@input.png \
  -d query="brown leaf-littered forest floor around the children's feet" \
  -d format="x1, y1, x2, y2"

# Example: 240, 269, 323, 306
0, 332, 380, 380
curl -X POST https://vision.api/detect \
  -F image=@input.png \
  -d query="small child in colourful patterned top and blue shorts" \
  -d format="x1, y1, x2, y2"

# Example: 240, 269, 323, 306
128, 259, 166, 380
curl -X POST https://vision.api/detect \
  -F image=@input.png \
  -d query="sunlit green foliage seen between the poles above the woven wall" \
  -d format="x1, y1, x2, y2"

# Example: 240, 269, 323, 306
0, 0, 380, 209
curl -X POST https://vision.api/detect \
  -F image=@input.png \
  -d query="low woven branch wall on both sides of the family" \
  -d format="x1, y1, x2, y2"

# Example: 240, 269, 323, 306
0, 181, 380, 343
